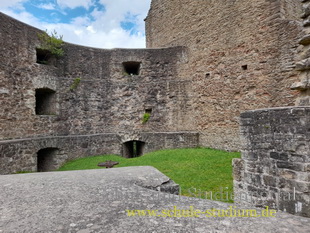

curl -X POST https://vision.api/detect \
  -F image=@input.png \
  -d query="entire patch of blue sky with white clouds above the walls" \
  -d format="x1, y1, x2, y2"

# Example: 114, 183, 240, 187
0, 0, 151, 48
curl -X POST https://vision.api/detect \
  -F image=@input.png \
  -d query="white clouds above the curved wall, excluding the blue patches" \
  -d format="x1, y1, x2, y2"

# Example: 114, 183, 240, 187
0, 0, 151, 48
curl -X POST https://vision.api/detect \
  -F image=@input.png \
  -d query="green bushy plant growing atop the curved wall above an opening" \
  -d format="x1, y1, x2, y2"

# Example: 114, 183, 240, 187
38, 30, 64, 57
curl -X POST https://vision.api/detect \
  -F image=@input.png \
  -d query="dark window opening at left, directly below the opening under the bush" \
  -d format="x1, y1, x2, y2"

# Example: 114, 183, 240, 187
36, 88, 56, 115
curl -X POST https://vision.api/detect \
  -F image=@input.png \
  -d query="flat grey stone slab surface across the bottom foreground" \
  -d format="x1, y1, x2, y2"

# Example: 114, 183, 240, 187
0, 167, 310, 233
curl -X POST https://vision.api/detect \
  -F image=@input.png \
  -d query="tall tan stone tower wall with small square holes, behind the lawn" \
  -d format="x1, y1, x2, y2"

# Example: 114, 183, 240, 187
146, 0, 303, 150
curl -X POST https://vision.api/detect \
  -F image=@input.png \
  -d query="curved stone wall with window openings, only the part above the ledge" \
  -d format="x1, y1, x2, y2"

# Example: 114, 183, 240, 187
0, 11, 191, 139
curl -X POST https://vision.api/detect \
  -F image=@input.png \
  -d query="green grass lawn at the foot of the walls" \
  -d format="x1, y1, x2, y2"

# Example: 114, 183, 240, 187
59, 148, 240, 203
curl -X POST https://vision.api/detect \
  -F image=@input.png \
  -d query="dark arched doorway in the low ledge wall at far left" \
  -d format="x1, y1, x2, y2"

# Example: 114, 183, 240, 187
37, 148, 59, 172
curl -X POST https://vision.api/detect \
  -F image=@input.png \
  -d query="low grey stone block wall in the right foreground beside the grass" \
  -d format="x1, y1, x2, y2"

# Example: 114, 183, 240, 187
233, 107, 310, 217
